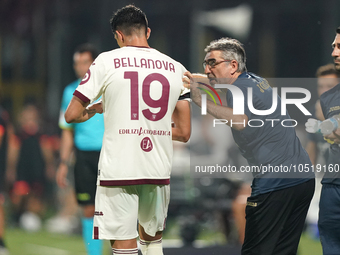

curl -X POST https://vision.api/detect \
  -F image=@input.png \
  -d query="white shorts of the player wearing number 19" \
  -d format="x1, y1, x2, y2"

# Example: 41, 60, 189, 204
93, 184, 170, 240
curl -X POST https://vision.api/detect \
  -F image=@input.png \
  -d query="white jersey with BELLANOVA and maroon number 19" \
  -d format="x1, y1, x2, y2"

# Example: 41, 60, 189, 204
74, 46, 189, 186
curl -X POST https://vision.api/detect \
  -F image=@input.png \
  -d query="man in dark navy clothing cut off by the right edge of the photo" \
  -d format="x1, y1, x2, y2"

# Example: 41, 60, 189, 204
318, 27, 340, 255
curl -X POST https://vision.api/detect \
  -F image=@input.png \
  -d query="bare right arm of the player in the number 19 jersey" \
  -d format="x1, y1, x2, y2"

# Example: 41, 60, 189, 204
172, 100, 191, 142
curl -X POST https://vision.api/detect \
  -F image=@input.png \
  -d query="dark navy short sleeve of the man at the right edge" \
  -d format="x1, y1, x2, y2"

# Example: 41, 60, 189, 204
320, 84, 340, 119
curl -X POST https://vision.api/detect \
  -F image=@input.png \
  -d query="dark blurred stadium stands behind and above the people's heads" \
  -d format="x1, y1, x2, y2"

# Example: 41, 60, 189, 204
0, 0, 340, 254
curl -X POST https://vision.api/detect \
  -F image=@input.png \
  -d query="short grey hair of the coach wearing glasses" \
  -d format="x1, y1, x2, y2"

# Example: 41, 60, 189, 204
204, 37, 247, 72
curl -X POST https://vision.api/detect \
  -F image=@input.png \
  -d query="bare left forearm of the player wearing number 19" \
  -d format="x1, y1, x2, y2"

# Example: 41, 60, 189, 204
65, 96, 97, 123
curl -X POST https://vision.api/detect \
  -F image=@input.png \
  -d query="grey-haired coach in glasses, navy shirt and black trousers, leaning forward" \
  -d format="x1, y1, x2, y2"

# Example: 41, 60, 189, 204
186, 38, 315, 255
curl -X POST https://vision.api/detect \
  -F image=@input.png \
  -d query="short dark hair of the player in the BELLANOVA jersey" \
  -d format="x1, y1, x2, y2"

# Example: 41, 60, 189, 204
110, 5, 148, 36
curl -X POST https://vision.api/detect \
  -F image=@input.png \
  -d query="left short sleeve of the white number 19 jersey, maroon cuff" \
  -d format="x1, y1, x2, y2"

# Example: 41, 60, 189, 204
73, 54, 106, 103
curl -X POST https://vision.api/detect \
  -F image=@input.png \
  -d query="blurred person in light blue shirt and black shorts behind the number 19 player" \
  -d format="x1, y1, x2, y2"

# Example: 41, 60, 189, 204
56, 44, 104, 255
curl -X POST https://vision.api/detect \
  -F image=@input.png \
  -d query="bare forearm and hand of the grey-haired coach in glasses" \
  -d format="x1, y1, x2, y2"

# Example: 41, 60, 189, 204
183, 72, 248, 131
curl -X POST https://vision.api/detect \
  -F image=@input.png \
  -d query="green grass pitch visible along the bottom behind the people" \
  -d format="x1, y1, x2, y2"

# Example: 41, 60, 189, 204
6, 229, 322, 255
